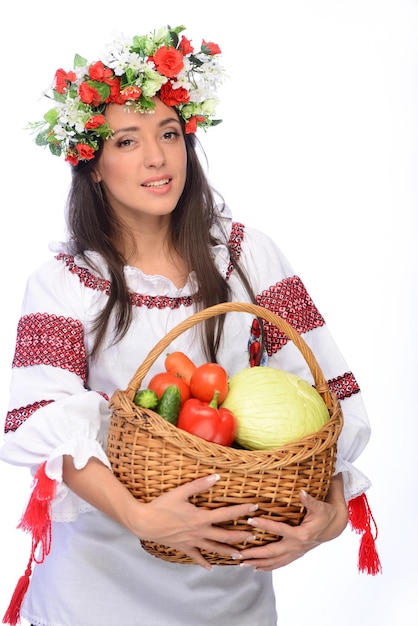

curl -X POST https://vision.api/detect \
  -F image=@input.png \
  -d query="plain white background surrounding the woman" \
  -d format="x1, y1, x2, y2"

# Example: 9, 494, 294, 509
0, 0, 418, 626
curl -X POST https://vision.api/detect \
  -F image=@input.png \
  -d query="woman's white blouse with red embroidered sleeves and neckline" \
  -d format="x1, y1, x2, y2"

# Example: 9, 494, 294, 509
0, 212, 370, 626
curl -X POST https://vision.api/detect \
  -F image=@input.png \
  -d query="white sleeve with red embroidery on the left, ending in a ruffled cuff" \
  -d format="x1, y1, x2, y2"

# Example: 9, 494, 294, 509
0, 259, 110, 521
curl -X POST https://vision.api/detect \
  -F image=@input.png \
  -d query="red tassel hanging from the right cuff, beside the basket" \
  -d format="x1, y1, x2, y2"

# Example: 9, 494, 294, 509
348, 493, 382, 576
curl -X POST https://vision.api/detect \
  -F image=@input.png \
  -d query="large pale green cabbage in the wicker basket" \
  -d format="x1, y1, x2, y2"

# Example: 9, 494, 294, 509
222, 367, 330, 450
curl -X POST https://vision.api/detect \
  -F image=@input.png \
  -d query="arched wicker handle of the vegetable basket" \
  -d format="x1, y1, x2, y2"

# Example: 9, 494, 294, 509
125, 302, 332, 408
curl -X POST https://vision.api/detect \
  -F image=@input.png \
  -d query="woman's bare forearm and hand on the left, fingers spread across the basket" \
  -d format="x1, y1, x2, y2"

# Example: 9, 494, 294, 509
63, 456, 257, 569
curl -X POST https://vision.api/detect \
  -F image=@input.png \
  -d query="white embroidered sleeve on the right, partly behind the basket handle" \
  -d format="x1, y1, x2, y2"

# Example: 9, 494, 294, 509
232, 228, 370, 501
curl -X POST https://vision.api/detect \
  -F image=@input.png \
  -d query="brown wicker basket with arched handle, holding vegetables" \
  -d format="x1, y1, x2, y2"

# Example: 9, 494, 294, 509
108, 302, 343, 565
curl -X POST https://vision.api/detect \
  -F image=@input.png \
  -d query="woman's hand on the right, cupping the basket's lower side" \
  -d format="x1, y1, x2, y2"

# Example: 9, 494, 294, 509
237, 474, 348, 571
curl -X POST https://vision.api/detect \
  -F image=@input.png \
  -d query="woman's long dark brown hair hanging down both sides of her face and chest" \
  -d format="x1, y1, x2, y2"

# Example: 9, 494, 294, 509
67, 134, 254, 361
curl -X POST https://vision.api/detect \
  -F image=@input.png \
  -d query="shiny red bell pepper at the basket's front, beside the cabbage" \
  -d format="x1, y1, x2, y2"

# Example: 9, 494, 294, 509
177, 398, 237, 446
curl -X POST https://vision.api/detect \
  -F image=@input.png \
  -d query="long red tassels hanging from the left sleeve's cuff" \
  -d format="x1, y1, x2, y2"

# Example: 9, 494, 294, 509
3, 462, 56, 626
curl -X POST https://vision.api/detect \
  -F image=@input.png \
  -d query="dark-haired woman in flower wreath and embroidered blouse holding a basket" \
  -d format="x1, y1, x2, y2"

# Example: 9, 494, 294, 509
1, 27, 378, 626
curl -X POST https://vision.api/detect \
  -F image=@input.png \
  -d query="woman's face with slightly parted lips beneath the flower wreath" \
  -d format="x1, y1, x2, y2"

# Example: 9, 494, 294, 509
93, 98, 187, 228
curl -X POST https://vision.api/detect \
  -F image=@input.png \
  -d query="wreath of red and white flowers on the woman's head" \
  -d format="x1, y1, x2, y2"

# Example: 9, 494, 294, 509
30, 26, 224, 165
